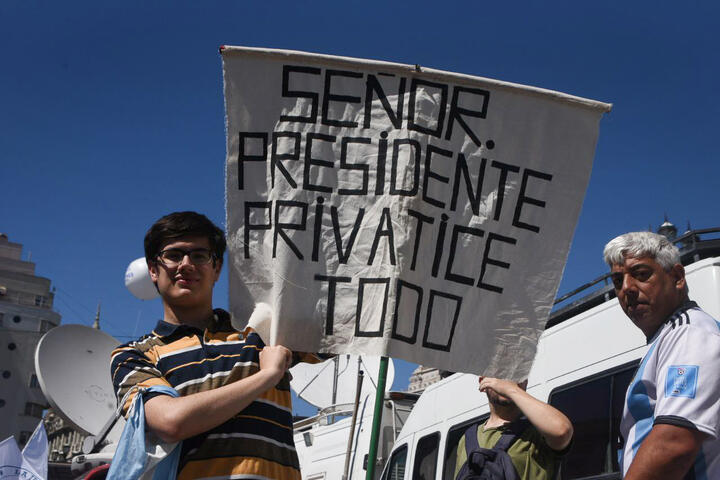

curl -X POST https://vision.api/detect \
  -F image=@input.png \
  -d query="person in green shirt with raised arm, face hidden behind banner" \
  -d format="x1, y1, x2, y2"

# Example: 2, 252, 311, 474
455, 377, 573, 480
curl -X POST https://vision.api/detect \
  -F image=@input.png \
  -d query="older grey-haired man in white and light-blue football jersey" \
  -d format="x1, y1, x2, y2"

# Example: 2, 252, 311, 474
603, 232, 720, 480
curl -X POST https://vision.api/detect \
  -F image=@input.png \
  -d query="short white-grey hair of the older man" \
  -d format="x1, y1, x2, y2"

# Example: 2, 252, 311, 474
603, 232, 680, 271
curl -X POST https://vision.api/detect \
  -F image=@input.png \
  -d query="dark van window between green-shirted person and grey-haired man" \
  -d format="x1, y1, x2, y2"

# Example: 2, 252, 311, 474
550, 362, 637, 480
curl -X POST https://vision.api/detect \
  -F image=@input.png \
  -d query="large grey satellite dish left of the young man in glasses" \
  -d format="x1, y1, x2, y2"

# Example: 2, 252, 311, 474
35, 325, 120, 435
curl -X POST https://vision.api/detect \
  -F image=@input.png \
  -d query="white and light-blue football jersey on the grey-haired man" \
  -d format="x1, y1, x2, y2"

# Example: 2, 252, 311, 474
619, 302, 720, 480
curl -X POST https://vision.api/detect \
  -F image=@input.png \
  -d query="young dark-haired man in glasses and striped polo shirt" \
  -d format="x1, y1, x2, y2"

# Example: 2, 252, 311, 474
111, 212, 310, 480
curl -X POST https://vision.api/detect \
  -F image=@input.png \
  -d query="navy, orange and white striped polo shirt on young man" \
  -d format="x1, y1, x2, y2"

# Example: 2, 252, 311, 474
111, 310, 317, 480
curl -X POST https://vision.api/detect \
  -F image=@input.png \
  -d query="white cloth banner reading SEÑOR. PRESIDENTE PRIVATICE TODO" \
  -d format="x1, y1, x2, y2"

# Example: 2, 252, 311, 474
222, 47, 610, 379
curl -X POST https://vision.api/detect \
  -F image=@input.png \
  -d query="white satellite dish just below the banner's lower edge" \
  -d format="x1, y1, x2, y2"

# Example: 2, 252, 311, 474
290, 354, 395, 408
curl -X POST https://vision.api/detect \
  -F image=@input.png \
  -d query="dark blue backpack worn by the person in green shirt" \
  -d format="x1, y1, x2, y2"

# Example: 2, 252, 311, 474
455, 419, 528, 480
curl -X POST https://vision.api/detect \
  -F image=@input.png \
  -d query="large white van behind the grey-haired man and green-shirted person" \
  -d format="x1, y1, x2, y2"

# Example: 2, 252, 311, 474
381, 244, 720, 480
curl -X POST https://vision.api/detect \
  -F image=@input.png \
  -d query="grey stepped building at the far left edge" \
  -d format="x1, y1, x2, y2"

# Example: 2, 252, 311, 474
0, 233, 60, 446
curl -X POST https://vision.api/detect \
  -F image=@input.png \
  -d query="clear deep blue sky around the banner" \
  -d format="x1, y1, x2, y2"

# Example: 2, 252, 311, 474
0, 0, 720, 416
